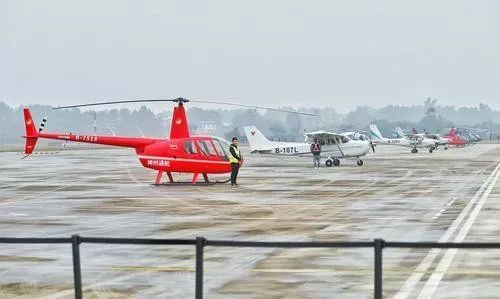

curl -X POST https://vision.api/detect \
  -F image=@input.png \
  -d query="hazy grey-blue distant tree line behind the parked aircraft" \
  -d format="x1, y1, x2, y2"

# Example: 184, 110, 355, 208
0, 98, 500, 144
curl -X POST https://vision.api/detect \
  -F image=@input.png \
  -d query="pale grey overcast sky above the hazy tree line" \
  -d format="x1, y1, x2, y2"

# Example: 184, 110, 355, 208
0, 0, 500, 111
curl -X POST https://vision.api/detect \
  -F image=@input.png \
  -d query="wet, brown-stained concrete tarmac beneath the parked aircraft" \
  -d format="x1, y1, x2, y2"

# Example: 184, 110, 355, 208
0, 144, 500, 298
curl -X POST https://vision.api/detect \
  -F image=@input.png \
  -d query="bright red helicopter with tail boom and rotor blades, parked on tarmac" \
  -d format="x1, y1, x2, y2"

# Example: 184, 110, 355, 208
23, 98, 313, 185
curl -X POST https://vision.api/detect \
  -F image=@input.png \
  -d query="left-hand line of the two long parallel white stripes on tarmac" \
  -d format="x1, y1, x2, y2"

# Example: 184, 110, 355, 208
394, 163, 500, 299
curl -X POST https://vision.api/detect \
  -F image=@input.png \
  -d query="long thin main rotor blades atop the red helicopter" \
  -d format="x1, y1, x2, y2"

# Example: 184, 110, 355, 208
53, 98, 316, 116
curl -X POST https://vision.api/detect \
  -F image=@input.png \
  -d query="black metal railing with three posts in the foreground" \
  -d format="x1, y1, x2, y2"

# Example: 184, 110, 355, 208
0, 235, 500, 299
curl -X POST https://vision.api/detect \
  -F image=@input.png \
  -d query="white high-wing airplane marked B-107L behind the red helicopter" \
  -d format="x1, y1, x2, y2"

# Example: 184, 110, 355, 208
243, 126, 370, 167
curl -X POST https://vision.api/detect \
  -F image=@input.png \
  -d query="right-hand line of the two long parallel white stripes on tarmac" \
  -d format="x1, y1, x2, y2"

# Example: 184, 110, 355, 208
418, 162, 500, 299
